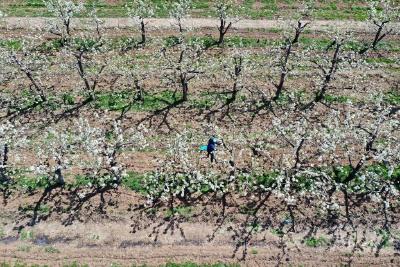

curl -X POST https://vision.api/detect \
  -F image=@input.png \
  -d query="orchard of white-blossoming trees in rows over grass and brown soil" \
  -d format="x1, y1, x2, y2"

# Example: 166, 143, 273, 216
0, 0, 400, 266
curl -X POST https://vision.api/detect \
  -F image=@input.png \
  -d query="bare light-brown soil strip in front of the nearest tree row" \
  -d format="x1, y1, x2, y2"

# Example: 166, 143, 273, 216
0, 191, 400, 266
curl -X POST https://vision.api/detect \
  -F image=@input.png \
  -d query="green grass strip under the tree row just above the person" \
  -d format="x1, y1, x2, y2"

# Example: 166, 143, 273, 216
3, 87, 400, 117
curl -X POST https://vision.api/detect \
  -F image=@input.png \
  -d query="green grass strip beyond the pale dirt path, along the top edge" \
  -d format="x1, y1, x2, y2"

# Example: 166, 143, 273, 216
0, 0, 376, 20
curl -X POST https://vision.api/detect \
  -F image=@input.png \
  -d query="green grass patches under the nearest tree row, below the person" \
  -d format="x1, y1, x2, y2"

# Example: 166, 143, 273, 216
4, 164, 400, 229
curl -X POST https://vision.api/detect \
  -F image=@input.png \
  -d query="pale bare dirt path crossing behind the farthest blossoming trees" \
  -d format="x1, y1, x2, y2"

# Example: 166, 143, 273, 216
0, 17, 400, 34
